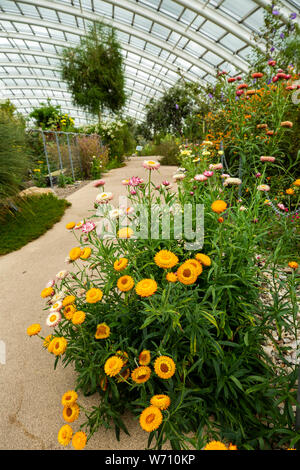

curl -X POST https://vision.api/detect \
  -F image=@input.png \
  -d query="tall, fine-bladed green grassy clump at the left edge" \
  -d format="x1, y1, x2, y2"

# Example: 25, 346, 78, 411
0, 108, 29, 204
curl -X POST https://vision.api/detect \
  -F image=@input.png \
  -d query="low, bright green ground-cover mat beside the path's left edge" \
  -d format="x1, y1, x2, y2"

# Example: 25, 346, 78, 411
0, 194, 71, 255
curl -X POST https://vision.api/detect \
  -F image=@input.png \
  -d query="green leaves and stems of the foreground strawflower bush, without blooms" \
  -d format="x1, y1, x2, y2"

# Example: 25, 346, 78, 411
38, 164, 300, 450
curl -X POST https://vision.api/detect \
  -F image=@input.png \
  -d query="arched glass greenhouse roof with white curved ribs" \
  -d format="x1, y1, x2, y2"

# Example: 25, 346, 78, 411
0, 0, 300, 124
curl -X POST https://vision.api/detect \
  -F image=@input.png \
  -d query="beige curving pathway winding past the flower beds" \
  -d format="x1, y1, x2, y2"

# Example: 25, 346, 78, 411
0, 157, 175, 450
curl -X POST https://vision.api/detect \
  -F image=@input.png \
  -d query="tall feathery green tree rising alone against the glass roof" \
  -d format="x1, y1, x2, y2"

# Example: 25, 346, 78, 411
61, 23, 126, 122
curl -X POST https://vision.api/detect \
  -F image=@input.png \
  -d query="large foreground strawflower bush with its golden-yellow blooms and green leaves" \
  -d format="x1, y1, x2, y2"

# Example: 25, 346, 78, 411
28, 157, 300, 450
